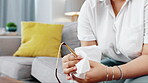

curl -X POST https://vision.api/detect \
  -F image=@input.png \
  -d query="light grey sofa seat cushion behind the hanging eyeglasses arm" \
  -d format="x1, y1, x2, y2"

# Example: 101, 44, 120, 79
31, 57, 68, 83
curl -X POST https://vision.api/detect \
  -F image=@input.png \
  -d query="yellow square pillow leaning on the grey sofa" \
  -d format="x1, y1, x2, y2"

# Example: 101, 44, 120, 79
14, 22, 63, 57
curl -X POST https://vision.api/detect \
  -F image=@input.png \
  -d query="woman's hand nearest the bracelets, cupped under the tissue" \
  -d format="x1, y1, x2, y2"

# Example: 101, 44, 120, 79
72, 60, 106, 83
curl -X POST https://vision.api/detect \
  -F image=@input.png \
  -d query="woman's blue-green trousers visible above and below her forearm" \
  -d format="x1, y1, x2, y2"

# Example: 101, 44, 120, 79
101, 58, 148, 83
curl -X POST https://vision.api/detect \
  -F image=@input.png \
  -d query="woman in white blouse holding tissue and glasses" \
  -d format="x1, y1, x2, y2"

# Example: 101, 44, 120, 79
62, 0, 148, 83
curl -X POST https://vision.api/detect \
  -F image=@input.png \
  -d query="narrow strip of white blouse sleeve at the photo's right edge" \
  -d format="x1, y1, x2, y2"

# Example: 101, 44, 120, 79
144, 3, 148, 44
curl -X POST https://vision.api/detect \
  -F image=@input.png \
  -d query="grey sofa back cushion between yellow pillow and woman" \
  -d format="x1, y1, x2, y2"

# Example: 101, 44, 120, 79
62, 22, 80, 56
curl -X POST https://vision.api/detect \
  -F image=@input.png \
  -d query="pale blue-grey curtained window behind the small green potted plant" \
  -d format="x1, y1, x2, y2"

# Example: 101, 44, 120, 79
0, 0, 35, 32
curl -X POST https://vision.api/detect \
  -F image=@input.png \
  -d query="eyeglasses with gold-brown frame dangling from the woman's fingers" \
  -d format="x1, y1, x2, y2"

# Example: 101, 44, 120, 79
55, 42, 78, 83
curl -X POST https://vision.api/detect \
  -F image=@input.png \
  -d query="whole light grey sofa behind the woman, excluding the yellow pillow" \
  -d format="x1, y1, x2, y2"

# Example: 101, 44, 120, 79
0, 22, 80, 83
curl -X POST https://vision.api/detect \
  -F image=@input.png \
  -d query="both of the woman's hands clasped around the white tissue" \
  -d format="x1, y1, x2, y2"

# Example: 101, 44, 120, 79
62, 54, 106, 83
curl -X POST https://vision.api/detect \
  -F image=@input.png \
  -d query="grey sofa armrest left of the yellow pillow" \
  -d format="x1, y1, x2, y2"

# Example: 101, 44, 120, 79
0, 36, 21, 56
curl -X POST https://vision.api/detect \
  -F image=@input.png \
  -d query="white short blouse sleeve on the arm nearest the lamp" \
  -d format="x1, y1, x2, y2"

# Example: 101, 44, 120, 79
78, 0, 96, 41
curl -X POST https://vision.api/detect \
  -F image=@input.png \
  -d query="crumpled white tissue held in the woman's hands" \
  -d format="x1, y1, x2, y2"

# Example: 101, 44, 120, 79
75, 46, 102, 79
